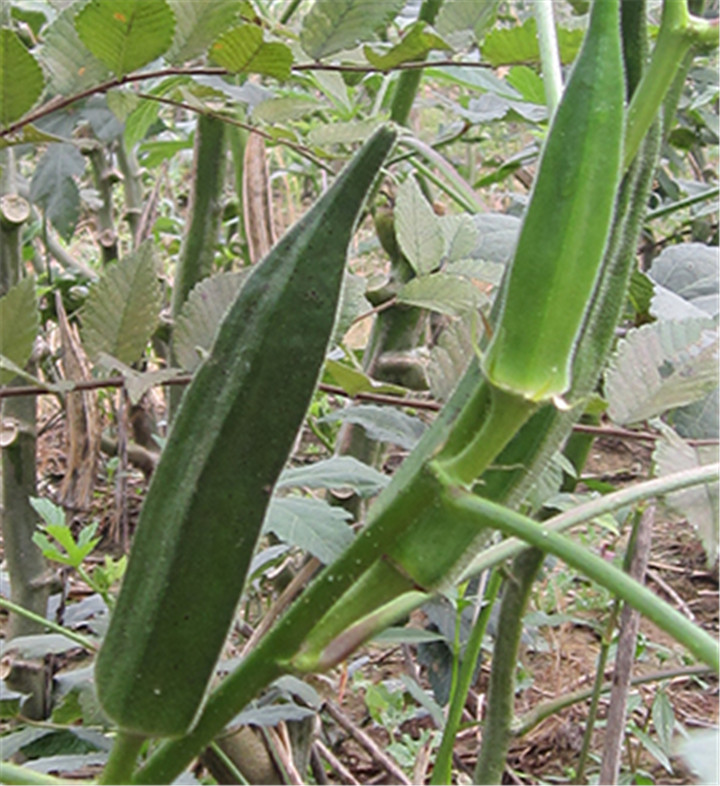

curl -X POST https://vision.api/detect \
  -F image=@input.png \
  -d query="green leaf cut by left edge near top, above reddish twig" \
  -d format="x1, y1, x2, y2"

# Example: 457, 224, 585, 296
0, 27, 45, 126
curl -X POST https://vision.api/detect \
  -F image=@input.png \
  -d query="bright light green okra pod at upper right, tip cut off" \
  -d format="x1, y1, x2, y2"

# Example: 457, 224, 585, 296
484, 0, 625, 401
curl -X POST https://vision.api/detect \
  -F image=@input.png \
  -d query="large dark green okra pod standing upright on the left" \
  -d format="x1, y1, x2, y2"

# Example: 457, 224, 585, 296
95, 128, 395, 736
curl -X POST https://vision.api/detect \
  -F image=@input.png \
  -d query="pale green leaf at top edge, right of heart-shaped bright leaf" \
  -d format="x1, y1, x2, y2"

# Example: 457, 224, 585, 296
165, 0, 244, 65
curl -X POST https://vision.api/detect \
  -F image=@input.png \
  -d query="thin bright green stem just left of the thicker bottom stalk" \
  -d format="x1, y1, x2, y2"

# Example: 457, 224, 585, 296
430, 570, 502, 785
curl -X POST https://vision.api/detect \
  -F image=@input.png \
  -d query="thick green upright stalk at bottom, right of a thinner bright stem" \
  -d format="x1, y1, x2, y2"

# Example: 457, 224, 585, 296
474, 548, 545, 784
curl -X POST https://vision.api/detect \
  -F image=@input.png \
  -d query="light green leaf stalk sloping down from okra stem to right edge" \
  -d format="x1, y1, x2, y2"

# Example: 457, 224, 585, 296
454, 488, 720, 671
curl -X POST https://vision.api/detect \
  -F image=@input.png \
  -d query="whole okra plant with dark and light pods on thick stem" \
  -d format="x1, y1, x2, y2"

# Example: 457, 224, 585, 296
3, 0, 719, 784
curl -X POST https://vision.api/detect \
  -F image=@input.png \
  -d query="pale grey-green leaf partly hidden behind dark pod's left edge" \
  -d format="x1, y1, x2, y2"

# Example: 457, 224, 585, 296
172, 271, 250, 371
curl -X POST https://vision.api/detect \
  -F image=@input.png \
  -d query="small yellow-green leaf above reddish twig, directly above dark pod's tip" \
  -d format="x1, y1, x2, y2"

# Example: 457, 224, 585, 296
210, 25, 293, 81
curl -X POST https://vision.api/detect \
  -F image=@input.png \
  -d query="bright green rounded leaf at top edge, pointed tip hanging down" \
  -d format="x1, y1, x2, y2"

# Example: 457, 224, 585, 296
75, 0, 175, 76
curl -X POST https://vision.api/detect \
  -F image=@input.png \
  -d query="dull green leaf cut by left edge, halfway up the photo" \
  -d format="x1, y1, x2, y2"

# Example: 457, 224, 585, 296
0, 278, 39, 385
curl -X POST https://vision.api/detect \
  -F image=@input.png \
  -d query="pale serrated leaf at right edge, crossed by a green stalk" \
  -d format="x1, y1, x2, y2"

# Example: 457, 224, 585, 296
653, 423, 719, 565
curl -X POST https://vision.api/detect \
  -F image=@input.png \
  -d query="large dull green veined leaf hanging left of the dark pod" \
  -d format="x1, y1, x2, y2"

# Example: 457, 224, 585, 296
82, 242, 162, 365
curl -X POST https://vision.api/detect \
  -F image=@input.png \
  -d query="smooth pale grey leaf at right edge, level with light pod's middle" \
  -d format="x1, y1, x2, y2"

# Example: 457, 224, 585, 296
648, 243, 720, 319
